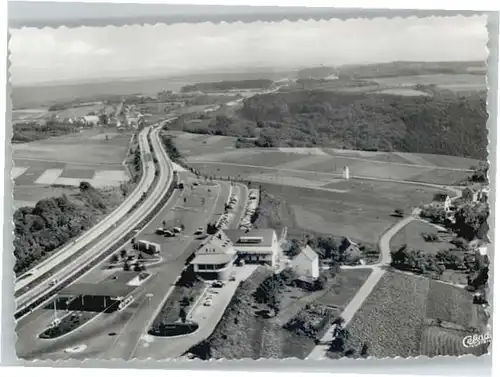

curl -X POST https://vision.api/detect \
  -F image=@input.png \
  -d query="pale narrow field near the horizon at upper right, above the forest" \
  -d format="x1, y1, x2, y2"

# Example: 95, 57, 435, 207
370, 73, 486, 91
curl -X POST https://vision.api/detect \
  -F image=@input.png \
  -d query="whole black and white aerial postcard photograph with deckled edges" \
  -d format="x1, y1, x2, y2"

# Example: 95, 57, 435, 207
4, 8, 493, 361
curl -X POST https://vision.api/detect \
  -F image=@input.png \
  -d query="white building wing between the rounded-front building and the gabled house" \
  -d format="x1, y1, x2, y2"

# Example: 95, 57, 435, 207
224, 229, 280, 267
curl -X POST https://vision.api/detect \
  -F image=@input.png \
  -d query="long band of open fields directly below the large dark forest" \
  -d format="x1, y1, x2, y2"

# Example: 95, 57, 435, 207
171, 131, 479, 184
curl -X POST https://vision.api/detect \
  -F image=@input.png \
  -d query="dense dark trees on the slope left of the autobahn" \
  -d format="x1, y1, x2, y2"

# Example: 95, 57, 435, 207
13, 182, 107, 274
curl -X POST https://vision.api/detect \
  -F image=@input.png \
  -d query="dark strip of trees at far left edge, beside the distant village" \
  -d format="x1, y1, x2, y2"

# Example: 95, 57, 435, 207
12, 119, 77, 143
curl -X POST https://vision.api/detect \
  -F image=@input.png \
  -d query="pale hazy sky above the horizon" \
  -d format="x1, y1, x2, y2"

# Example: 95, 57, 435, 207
9, 16, 488, 86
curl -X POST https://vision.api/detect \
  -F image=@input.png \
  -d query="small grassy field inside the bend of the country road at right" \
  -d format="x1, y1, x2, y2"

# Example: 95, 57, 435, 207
390, 221, 456, 254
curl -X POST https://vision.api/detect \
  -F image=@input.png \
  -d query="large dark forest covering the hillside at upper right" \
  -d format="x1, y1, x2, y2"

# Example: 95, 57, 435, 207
236, 90, 487, 159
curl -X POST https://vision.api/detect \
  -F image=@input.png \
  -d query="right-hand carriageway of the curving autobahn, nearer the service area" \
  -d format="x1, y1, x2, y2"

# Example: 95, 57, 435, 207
17, 125, 173, 314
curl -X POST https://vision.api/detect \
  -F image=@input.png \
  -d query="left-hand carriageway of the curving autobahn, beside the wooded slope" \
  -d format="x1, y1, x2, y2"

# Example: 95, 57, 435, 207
15, 128, 154, 293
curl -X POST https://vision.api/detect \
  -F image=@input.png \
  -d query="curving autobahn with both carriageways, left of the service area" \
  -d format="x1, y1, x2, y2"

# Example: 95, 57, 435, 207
16, 124, 173, 318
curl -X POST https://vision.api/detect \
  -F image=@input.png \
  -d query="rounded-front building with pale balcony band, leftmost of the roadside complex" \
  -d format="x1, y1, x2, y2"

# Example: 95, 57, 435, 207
190, 232, 237, 280
